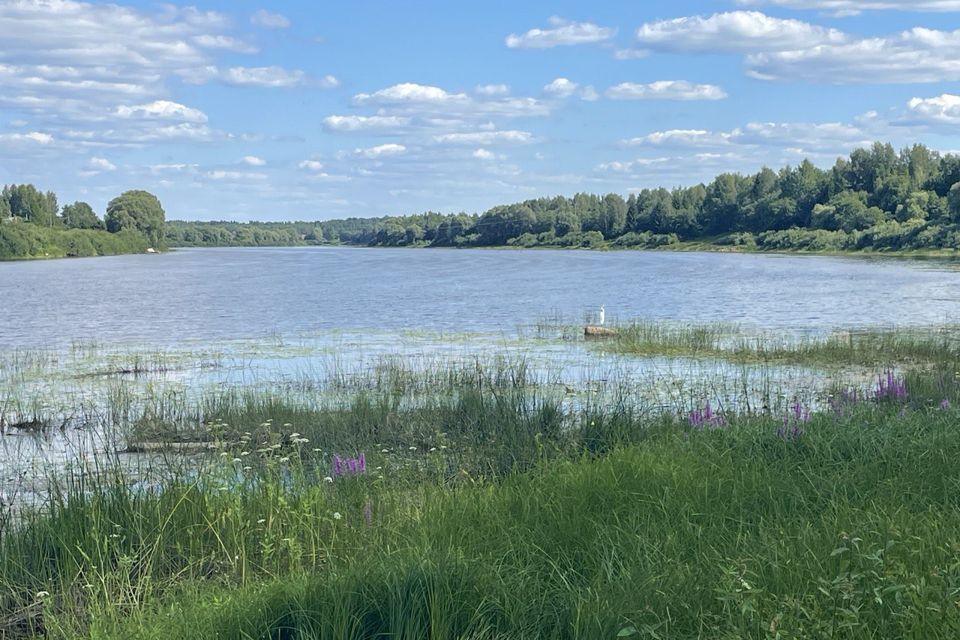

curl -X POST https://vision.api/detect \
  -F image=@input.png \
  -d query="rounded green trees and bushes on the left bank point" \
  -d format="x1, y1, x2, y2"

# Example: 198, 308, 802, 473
0, 184, 166, 259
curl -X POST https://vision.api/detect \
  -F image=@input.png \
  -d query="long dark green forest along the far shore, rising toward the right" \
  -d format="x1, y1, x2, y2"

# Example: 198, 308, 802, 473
167, 143, 960, 251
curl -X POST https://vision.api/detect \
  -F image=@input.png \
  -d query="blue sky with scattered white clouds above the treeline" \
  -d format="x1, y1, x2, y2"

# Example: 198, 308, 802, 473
0, 0, 960, 220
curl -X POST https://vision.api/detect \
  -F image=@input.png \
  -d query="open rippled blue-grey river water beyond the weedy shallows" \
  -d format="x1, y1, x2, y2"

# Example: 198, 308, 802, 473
0, 248, 960, 347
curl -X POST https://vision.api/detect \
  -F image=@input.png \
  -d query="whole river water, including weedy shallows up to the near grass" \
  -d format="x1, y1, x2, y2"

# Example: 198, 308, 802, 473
0, 248, 960, 504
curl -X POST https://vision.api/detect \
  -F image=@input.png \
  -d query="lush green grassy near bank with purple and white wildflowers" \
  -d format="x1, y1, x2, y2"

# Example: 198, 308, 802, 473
0, 358, 960, 639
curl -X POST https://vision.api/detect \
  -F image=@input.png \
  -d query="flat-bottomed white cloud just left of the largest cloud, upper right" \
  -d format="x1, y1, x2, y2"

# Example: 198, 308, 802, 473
637, 11, 847, 53
